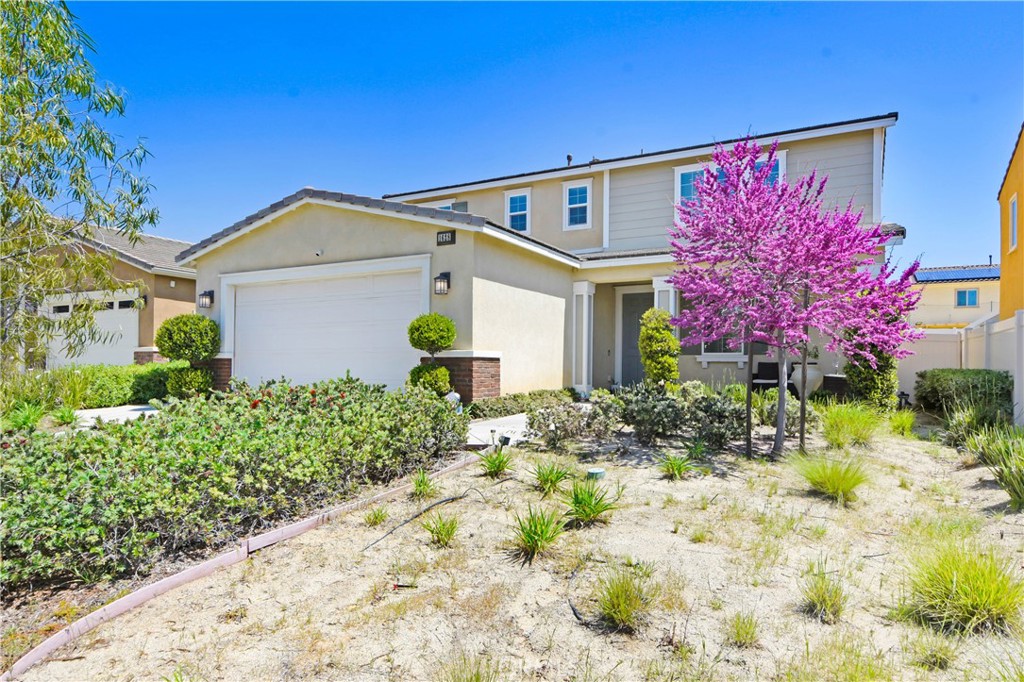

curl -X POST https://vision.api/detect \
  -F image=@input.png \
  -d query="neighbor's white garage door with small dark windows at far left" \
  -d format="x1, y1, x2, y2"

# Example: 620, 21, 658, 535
46, 292, 138, 369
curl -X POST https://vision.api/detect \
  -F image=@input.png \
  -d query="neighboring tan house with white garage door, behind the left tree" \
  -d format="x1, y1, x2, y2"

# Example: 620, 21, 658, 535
46, 228, 196, 368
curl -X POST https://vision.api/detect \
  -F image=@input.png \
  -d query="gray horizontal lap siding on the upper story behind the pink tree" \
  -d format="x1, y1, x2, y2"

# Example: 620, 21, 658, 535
608, 130, 873, 250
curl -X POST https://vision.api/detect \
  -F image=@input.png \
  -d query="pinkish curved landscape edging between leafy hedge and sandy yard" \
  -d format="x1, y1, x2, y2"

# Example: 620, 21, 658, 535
0, 455, 477, 682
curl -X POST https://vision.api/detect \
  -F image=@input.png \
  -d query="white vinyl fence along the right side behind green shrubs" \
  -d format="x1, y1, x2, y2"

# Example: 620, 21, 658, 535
899, 310, 1024, 424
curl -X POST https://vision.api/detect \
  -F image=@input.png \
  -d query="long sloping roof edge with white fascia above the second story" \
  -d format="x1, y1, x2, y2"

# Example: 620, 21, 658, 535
384, 112, 899, 199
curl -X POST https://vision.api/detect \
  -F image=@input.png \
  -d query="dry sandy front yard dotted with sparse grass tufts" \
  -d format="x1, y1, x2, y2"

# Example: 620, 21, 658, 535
14, 428, 1024, 681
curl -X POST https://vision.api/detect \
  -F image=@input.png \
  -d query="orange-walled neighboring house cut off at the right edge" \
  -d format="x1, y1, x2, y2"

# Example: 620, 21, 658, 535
998, 125, 1024, 319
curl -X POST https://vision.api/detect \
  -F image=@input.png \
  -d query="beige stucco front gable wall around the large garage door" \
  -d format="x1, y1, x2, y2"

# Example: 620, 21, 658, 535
190, 204, 475, 349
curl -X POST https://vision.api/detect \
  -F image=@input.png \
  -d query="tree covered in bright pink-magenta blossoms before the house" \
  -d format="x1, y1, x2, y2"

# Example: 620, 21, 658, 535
671, 140, 921, 455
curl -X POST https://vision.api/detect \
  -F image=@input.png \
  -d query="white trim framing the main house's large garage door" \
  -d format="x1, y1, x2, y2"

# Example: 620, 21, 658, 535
218, 254, 431, 357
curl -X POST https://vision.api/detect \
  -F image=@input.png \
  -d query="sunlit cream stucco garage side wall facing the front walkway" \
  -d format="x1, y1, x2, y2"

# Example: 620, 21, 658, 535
472, 237, 572, 393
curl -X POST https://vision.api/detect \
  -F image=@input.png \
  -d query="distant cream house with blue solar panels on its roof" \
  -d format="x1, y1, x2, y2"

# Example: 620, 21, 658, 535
910, 264, 999, 329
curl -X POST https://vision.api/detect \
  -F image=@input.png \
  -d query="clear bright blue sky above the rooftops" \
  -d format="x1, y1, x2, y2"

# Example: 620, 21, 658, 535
72, 2, 1024, 265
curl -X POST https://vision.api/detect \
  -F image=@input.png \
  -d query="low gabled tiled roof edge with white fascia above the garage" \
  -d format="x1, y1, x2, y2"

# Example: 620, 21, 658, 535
176, 187, 579, 265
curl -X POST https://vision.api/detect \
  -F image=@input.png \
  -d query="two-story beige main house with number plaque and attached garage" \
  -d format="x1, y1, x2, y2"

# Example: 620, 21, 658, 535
178, 114, 902, 400
